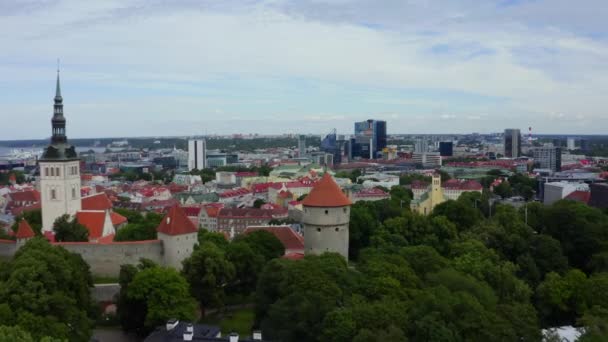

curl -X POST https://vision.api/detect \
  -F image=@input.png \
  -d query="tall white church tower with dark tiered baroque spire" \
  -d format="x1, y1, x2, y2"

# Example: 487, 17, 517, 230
38, 70, 81, 232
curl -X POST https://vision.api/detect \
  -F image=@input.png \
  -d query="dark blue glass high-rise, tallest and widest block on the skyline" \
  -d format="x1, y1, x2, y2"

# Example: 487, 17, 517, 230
351, 119, 386, 159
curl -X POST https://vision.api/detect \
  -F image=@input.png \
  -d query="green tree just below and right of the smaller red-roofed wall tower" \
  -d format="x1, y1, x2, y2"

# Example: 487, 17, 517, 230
182, 242, 235, 316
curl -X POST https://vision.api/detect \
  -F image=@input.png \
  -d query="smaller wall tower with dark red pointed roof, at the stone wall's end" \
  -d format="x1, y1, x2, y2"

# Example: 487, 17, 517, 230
156, 205, 198, 269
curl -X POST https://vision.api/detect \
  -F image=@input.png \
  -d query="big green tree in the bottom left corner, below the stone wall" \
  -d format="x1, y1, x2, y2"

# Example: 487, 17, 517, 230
0, 238, 96, 341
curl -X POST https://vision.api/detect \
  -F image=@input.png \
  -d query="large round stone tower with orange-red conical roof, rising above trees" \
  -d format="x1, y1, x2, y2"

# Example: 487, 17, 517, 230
302, 172, 352, 260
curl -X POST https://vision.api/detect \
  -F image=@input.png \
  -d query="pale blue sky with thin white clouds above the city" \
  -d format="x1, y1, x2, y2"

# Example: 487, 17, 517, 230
0, 0, 608, 140
